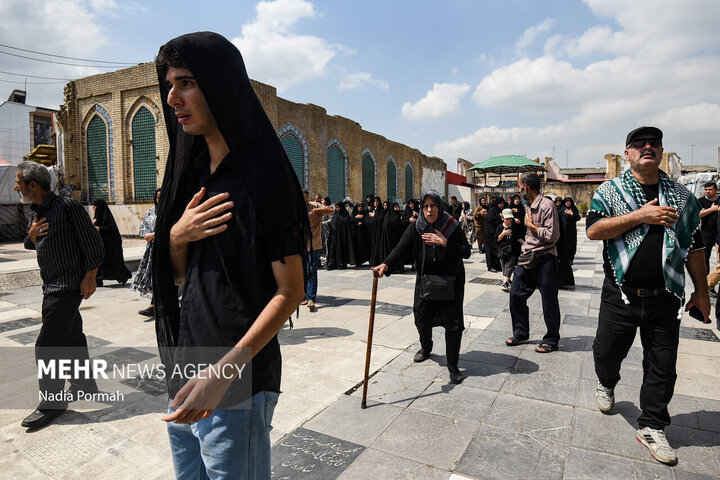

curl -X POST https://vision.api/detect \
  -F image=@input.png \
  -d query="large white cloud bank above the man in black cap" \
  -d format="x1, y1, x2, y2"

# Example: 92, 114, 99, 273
444, 0, 720, 166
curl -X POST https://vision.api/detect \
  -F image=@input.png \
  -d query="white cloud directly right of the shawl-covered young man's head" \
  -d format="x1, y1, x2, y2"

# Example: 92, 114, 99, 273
232, 0, 342, 91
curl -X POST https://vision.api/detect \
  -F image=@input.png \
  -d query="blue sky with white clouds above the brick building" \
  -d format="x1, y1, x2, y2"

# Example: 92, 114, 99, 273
0, 0, 720, 170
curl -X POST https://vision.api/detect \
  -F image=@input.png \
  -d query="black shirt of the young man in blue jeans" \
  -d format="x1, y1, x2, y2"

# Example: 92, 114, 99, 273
178, 157, 304, 398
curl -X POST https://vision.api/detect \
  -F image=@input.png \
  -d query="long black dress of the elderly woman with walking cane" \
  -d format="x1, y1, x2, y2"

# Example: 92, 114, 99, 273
383, 219, 470, 366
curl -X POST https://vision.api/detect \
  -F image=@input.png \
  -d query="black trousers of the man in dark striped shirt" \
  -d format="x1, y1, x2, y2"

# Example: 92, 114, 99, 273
35, 290, 92, 408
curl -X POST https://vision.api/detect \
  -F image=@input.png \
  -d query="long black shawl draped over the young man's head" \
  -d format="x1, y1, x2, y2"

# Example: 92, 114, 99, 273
153, 32, 310, 353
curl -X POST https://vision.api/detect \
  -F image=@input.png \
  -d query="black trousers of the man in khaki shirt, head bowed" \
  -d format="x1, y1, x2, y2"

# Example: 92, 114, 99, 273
510, 253, 560, 345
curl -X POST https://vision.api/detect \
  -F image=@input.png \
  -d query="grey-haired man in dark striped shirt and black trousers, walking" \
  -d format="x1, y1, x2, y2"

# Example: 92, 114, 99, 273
14, 162, 105, 429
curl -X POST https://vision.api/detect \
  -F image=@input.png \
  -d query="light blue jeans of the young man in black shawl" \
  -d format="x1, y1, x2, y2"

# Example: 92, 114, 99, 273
167, 392, 279, 480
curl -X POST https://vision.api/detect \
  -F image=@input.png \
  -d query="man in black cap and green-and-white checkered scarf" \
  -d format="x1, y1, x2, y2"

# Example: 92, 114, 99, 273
586, 127, 710, 465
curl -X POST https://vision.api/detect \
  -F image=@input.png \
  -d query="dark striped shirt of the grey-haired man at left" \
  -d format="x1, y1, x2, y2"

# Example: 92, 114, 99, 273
24, 192, 105, 294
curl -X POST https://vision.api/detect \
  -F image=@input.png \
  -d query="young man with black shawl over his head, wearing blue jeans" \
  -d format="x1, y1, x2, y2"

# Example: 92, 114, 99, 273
153, 32, 309, 479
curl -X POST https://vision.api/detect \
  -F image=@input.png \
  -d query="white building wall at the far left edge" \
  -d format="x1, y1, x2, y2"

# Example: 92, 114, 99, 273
0, 102, 35, 165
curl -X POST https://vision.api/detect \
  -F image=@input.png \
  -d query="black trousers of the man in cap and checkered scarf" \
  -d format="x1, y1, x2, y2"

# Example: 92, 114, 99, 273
593, 279, 682, 430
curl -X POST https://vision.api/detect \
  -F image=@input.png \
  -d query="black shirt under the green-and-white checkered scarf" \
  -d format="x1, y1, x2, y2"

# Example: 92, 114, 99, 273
586, 183, 704, 288
